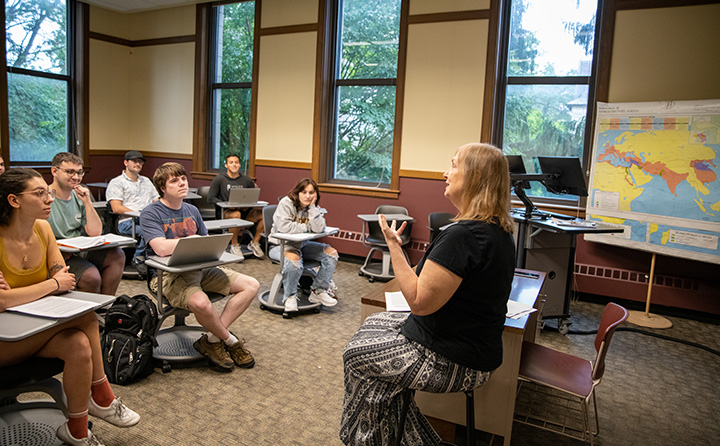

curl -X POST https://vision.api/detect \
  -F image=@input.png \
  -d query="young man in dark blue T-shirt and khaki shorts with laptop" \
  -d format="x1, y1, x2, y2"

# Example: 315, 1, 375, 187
140, 163, 260, 371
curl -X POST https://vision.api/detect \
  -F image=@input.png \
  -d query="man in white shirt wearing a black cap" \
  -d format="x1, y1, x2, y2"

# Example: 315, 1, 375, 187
105, 150, 160, 278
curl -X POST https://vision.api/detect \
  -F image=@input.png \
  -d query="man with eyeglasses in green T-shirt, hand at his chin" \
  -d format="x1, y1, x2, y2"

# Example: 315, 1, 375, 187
48, 152, 125, 295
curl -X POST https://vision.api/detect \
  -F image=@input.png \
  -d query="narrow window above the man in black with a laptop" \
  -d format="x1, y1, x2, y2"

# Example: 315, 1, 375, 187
207, 1, 255, 172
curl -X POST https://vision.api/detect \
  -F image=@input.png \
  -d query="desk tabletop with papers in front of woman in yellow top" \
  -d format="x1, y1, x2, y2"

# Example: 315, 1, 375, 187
0, 291, 115, 341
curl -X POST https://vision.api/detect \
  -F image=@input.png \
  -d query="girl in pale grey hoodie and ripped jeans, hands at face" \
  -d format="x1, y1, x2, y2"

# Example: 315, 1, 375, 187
270, 178, 338, 312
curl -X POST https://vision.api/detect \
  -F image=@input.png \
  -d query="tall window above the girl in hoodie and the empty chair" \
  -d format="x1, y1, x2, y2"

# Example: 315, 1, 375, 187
325, 0, 401, 188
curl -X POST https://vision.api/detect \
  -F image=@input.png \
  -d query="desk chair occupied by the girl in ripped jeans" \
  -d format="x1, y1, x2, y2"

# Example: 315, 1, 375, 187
258, 204, 321, 319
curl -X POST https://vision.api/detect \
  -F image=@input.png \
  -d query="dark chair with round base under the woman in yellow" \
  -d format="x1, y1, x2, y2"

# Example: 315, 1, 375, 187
0, 358, 68, 445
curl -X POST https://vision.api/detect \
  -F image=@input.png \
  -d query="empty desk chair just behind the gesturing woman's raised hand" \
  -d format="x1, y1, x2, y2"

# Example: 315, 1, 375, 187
358, 205, 412, 282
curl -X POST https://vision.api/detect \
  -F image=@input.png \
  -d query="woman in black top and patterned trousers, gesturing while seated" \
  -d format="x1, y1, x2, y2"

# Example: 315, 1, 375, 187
340, 144, 515, 445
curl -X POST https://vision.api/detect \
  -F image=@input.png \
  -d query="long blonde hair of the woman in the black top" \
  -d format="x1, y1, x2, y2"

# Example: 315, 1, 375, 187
456, 143, 513, 234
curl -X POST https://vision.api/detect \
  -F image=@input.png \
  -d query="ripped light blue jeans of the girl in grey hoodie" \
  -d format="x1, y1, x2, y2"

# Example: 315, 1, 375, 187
282, 241, 338, 297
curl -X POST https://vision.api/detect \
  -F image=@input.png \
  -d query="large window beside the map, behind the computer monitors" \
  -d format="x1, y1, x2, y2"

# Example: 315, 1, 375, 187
494, 0, 598, 199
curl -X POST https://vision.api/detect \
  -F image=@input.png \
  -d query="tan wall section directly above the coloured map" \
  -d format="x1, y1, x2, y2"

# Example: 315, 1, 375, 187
608, 4, 720, 102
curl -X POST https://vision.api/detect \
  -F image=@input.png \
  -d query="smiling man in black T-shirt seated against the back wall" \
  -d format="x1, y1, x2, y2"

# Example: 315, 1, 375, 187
208, 153, 265, 259
